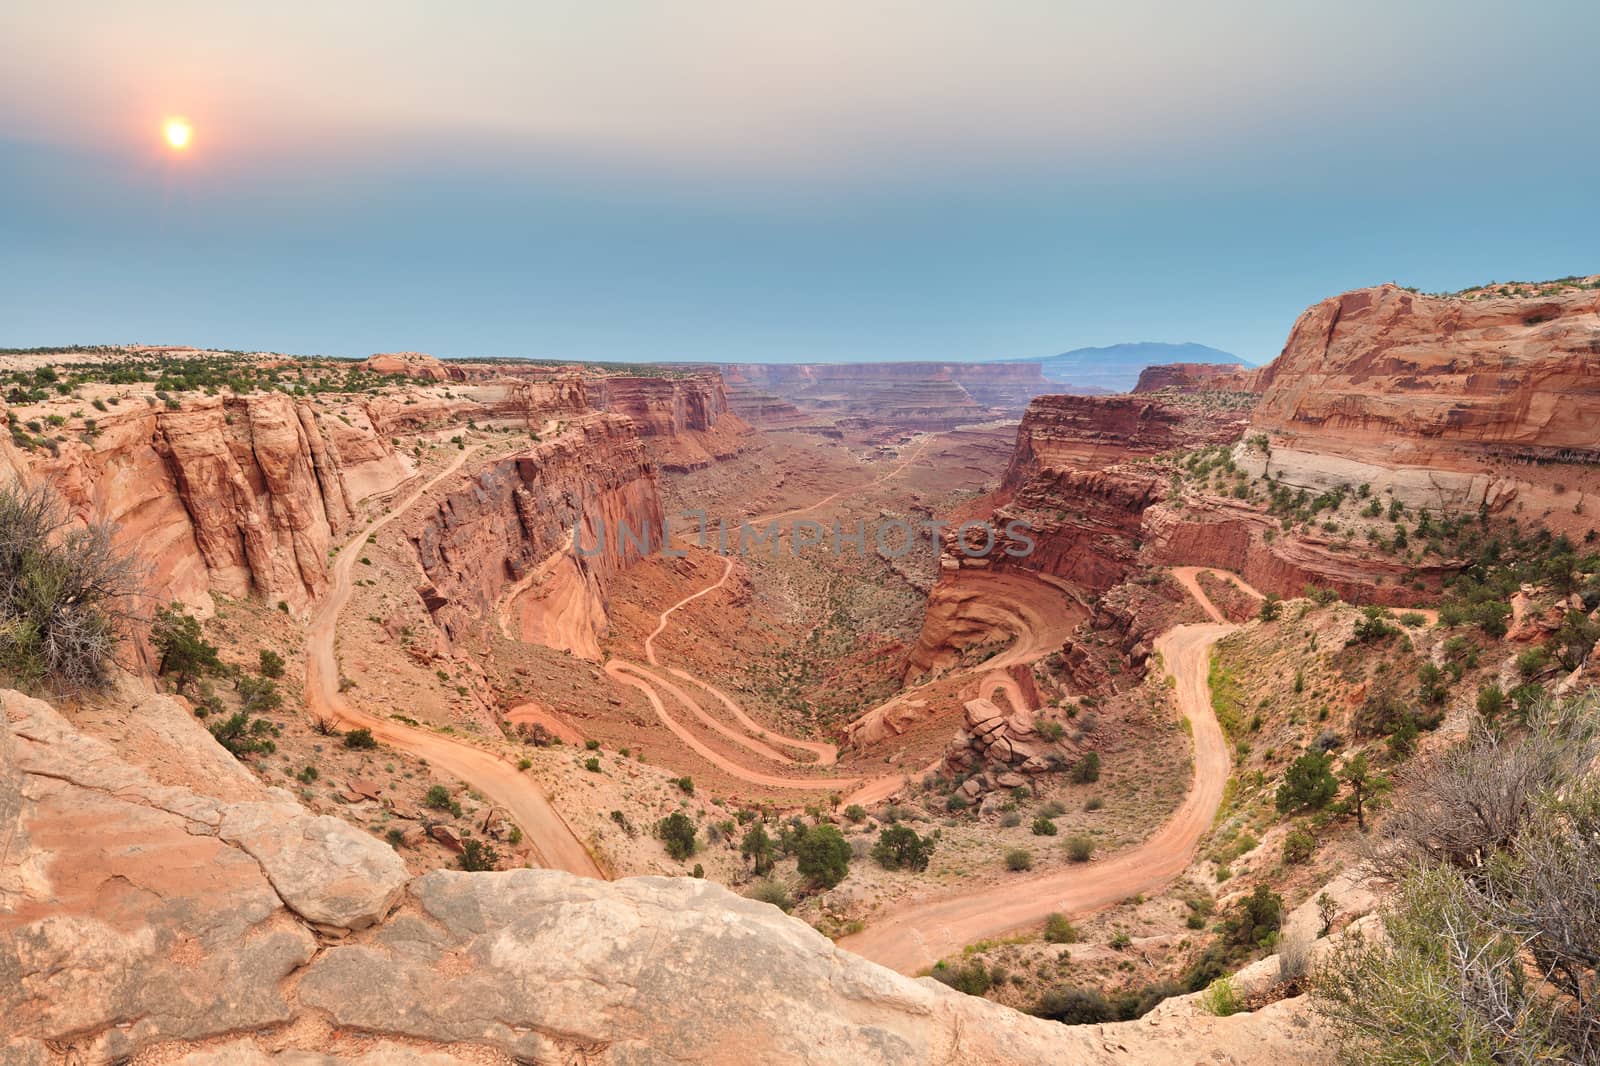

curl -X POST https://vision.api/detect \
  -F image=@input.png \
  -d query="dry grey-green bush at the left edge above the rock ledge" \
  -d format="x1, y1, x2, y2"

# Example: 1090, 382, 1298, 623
0, 480, 142, 691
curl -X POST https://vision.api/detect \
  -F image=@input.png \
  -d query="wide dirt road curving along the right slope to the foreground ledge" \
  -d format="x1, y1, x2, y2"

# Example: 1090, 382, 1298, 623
838, 568, 1254, 973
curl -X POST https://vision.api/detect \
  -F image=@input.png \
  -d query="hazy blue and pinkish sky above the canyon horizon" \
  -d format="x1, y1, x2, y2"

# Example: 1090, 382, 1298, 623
0, 0, 1600, 360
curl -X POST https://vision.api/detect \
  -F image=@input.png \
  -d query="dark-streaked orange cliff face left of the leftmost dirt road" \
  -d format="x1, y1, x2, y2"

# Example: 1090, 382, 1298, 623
29, 394, 413, 613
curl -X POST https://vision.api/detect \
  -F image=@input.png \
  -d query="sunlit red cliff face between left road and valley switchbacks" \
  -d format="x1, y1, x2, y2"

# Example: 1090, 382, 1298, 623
408, 415, 664, 658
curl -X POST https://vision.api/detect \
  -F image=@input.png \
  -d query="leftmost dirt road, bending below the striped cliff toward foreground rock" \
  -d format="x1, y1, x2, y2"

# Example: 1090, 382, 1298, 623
306, 448, 605, 877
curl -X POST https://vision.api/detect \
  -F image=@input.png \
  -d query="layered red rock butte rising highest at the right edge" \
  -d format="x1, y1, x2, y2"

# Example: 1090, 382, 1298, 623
1238, 285, 1600, 511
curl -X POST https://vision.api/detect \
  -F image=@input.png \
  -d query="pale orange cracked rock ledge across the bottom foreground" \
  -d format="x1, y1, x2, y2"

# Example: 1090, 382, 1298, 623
0, 693, 1317, 1066
